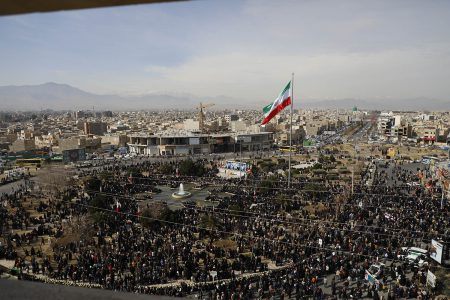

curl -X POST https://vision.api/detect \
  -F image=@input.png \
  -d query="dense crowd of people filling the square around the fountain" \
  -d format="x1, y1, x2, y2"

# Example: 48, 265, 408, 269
0, 155, 450, 299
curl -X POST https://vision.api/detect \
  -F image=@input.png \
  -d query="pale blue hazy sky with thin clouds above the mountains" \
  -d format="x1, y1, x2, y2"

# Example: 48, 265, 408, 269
0, 0, 450, 102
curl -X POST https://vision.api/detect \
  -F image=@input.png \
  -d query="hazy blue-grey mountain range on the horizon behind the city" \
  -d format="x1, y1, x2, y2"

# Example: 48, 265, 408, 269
0, 82, 450, 111
